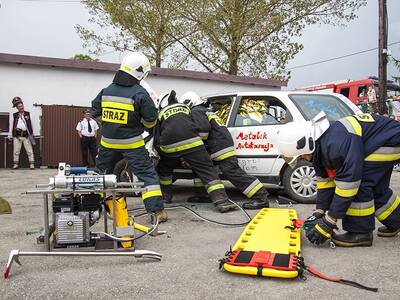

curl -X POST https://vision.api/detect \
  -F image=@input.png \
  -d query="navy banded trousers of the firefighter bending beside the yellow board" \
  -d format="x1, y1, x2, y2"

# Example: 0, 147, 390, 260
343, 162, 400, 233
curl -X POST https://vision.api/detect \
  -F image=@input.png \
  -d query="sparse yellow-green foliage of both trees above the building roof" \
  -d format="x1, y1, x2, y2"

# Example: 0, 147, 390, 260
78, 0, 366, 79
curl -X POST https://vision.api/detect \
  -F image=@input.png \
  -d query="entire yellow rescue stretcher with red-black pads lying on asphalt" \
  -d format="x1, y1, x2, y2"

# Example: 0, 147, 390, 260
221, 208, 302, 278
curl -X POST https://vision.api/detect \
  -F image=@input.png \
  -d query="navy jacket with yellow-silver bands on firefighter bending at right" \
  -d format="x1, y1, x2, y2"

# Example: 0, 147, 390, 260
313, 114, 400, 218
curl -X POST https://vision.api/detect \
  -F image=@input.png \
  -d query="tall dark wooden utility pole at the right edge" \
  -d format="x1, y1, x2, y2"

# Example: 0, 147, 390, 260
378, 0, 388, 114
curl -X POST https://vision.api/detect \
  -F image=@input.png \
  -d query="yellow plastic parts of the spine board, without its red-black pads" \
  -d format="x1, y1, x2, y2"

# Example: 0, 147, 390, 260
224, 208, 301, 278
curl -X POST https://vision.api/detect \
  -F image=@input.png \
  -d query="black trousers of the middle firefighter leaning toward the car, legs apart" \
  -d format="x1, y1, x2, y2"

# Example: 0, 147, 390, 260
157, 146, 228, 203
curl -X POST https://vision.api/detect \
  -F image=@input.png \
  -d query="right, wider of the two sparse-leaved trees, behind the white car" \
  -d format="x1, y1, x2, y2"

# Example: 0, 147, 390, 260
175, 0, 366, 78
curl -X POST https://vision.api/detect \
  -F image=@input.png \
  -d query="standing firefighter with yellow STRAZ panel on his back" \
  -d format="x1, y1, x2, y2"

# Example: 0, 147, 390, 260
92, 52, 168, 222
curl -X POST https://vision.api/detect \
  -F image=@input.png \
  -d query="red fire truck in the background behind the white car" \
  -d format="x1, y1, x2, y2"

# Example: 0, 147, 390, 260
297, 77, 400, 105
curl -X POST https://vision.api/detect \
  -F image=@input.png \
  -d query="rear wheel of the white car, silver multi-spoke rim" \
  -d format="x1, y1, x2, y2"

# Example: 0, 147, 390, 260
282, 160, 317, 204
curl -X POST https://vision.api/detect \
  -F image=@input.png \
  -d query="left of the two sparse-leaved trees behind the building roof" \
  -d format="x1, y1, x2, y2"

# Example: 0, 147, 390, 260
76, 0, 190, 67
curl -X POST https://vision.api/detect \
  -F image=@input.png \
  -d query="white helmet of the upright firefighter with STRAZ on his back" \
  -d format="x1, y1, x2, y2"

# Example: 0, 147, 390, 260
119, 52, 151, 81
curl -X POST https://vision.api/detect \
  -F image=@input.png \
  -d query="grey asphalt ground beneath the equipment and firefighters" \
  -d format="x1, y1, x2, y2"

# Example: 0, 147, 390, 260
0, 169, 400, 299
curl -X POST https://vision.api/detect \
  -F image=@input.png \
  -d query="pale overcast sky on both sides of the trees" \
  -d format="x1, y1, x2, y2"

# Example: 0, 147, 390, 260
0, 0, 400, 88
